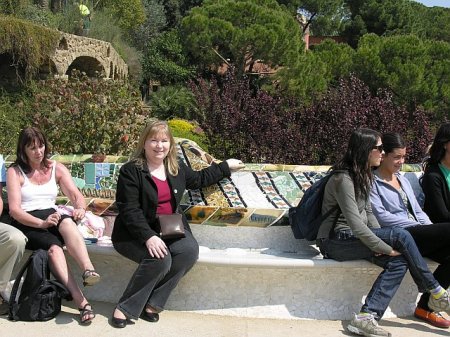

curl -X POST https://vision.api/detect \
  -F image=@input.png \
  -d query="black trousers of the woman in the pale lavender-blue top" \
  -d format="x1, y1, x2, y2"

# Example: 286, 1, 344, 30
406, 223, 450, 310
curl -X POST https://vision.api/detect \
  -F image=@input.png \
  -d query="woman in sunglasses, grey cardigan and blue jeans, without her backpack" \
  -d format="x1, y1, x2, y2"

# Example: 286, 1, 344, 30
318, 129, 450, 336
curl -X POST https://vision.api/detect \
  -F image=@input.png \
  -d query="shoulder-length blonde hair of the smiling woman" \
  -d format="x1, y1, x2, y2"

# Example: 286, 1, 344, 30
131, 119, 179, 176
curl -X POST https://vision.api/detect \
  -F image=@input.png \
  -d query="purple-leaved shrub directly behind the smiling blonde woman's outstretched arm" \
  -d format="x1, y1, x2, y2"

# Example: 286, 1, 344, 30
191, 72, 304, 163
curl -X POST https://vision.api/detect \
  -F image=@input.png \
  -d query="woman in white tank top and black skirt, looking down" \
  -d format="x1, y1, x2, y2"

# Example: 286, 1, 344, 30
7, 127, 100, 324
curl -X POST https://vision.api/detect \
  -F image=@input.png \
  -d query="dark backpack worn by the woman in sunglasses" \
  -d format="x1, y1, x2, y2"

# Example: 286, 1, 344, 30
289, 170, 345, 241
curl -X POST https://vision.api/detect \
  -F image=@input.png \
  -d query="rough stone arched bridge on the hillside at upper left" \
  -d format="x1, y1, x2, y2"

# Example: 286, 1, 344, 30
45, 32, 128, 79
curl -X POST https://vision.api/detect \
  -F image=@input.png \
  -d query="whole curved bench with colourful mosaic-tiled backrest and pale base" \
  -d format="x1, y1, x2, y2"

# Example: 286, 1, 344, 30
5, 139, 432, 319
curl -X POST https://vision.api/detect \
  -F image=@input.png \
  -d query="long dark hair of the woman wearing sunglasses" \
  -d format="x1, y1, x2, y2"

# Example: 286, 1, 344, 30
331, 128, 381, 199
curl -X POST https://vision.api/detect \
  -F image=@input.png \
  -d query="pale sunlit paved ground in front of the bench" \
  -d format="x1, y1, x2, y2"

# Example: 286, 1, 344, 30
0, 302, 450, 337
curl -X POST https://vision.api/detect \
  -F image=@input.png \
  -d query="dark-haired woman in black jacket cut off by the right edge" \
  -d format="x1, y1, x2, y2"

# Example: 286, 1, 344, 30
422, 123, 450, 223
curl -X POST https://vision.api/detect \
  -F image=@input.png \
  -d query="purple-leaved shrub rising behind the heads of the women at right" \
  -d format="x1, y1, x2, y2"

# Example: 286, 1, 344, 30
299, 76, 432, 164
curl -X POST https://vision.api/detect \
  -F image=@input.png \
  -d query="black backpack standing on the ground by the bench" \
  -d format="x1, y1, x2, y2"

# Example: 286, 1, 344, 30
8, 249, 71, 321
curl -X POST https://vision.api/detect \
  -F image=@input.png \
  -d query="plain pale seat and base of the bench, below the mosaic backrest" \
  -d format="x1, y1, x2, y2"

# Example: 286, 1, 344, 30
71, 225, 436, 319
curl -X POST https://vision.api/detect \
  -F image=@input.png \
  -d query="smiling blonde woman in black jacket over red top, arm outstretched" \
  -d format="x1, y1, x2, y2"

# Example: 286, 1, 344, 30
112, 120, 243, 328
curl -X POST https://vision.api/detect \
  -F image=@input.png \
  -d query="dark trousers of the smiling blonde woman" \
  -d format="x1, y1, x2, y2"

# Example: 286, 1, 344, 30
114, 231, 198, 319
